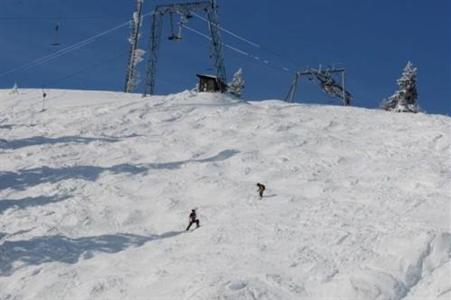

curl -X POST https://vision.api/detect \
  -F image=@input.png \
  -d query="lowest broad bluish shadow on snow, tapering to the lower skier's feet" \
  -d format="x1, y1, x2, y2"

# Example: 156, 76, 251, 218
0, 231, 184, 276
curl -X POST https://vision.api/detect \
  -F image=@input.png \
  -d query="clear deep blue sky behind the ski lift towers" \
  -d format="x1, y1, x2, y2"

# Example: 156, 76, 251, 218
0, 0, 451, 115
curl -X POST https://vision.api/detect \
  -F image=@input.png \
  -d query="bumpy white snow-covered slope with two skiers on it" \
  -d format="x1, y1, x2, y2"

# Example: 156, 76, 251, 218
0, 90, 451, 300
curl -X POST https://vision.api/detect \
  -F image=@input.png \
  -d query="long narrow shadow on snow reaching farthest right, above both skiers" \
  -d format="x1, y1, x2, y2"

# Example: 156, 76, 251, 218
0, 150, 239, 190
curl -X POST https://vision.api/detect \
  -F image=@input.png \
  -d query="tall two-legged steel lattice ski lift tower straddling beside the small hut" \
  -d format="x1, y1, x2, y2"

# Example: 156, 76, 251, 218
143, 0, 227, 96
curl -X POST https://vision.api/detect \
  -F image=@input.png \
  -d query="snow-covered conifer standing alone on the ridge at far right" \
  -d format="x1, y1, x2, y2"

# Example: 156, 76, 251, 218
381, 61, 419, 113
